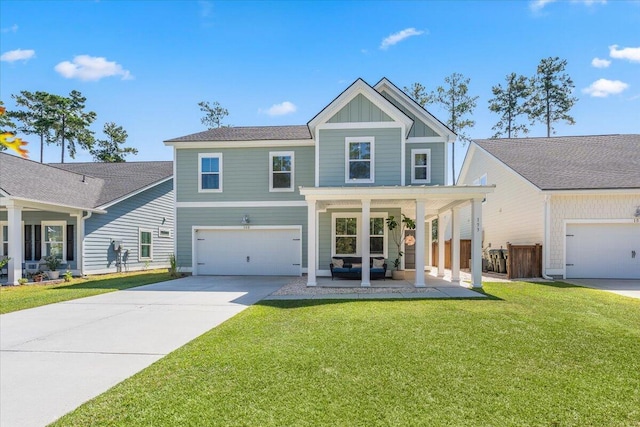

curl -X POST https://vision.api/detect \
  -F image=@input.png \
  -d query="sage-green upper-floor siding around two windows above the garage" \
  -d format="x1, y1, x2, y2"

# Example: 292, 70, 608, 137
175, 143, 315, 202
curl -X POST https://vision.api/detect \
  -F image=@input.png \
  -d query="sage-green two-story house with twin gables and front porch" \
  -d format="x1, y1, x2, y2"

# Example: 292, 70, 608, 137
165, 79, 492, 286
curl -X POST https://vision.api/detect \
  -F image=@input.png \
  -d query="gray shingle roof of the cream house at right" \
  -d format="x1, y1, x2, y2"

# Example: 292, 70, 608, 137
474, 134, 640, 190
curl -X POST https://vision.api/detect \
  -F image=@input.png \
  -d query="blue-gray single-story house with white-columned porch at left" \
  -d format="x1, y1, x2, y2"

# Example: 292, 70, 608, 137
0, 153, 174, 284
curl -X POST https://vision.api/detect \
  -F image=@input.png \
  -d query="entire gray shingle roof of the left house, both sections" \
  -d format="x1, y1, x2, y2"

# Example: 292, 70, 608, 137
0, 153, 173, 209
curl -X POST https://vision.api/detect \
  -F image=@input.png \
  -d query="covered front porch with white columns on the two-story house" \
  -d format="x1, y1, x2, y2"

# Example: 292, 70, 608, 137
300, 186, 494, 288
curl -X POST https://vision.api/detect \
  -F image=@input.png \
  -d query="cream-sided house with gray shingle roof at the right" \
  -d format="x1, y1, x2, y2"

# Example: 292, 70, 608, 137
458, 135, 640, 279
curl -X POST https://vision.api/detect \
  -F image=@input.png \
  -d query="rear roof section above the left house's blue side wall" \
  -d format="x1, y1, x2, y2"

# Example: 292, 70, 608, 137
50, 162, 173, 206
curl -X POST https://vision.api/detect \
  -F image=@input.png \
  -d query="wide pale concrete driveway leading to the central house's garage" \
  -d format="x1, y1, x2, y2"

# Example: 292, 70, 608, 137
0, 277, 284, 427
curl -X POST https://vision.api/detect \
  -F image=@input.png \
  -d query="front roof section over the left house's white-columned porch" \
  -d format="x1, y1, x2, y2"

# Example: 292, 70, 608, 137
0, 153, 104, 209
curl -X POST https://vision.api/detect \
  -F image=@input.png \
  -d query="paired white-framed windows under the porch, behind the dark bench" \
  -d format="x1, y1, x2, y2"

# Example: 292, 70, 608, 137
331, 212, 387, 257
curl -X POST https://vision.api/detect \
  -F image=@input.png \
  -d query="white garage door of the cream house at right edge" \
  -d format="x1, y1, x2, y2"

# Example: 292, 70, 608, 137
566, 223, 640, 279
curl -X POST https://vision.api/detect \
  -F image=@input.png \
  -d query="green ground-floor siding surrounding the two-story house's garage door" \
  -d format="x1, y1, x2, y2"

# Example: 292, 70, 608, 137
176, 206, 307, 269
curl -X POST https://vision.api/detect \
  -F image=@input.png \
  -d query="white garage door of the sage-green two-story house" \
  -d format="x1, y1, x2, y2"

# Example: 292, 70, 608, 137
194, 228, 302, 276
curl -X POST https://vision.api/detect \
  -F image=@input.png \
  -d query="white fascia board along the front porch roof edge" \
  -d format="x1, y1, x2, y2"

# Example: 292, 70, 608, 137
298, 185, 495, 200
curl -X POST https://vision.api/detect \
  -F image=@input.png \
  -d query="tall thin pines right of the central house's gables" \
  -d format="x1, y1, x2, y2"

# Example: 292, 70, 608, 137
403, 57, 578, 182
